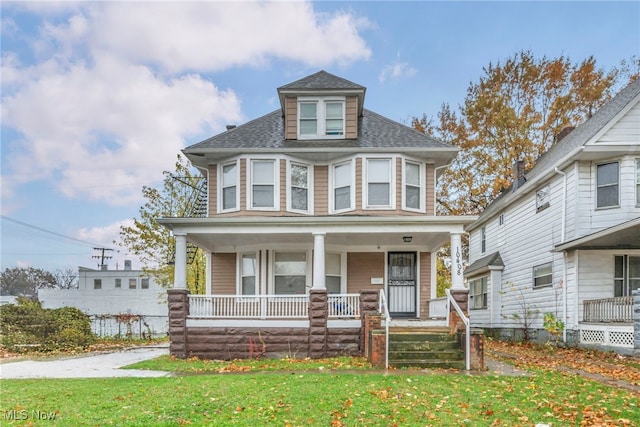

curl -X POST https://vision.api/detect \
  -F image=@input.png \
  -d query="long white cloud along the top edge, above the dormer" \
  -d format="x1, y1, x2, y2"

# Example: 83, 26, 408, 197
91, 2, 371, 72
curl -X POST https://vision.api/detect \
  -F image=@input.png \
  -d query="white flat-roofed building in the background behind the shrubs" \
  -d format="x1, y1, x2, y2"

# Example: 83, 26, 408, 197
38, 261, 168, 336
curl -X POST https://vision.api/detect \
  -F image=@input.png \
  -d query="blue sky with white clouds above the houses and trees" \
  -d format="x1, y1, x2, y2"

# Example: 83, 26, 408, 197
0, 1, 640, 270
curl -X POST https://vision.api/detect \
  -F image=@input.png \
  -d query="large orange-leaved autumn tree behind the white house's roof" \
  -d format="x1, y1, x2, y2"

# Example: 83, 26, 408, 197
412, 51, 640, 215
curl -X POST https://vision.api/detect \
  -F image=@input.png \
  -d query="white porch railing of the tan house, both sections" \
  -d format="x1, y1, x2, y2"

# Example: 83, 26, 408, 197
189, 294, 360, 319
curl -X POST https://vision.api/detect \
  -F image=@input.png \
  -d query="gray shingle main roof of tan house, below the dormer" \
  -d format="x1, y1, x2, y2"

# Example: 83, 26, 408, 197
184, 109, 454, 154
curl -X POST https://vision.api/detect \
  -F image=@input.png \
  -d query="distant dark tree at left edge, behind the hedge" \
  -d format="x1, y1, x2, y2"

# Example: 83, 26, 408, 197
0, 267, 57, 300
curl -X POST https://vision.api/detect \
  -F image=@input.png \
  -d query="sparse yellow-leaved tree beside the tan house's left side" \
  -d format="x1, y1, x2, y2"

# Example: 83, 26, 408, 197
118, 155, 206, 293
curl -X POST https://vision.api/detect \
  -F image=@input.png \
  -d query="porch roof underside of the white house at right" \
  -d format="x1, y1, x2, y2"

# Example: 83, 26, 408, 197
555, 218, 640, 252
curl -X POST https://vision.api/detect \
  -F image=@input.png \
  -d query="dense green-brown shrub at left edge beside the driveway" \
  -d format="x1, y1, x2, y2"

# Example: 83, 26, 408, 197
0, 298, 96, 352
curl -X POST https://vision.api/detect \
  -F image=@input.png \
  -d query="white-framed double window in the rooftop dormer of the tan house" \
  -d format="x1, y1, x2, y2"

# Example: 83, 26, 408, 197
298, 97, 345, 139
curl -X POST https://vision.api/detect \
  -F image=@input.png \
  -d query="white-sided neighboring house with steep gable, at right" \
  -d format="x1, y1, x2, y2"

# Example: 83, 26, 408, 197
465, 80, 640, 351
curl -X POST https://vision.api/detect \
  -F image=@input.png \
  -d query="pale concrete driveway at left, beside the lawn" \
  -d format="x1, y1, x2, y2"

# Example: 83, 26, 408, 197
0, 346, 171, 379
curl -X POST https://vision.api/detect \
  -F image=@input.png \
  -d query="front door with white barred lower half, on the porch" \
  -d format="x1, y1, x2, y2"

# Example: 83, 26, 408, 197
387, 252, 417, 318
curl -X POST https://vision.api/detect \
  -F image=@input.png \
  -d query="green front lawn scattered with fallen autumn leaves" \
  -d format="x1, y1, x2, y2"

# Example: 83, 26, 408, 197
0, 358, 640, 427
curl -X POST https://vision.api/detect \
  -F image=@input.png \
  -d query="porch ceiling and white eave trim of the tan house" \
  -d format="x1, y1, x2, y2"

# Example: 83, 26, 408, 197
159, 217, 475, 252
